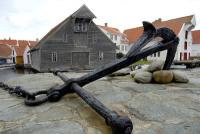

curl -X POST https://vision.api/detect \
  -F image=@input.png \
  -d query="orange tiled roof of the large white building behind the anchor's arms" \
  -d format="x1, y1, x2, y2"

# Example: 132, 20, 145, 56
124, 15, 194, 43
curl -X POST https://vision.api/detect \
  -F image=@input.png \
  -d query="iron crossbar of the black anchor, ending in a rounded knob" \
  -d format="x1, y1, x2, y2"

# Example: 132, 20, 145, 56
57, 72, 133, 134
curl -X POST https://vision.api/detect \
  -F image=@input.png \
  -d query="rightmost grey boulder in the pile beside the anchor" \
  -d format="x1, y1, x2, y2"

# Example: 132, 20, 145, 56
172, 70, 189, 83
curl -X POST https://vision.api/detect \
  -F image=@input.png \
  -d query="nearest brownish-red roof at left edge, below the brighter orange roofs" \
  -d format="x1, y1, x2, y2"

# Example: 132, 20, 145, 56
0, 44, 12, 58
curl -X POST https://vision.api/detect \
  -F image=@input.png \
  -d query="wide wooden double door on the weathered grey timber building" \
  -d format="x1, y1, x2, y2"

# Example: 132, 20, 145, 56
72, 52, 89, 68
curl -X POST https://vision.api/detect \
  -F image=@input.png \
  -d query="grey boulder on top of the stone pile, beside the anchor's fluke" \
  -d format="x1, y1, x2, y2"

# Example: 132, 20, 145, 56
147, 60, 164, 72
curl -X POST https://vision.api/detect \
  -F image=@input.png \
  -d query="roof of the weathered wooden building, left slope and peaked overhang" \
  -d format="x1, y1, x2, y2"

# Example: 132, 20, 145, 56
31, 5, 96, 51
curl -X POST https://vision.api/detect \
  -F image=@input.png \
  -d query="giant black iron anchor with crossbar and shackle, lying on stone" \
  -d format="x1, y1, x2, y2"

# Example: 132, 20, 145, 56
6, 22, 179, 134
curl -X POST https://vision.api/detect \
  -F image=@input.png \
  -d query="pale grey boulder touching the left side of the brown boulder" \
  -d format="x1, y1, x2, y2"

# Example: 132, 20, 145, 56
134, 72, 152, 83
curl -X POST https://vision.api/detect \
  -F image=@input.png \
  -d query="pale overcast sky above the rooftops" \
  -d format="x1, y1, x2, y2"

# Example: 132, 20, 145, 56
0, 0, 200, 40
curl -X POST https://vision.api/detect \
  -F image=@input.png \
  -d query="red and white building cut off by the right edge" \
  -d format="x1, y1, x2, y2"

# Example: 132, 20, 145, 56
191, 30, 200, 59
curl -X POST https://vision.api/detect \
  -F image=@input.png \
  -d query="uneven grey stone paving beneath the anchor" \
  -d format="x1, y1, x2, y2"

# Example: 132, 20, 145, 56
0, 69, 200, 134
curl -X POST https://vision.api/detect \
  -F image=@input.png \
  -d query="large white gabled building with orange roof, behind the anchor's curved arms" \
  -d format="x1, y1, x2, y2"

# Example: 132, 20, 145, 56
124, 15, 196, 61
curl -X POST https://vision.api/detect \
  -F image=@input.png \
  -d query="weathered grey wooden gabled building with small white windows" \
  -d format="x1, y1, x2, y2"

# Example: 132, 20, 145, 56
30, 5, 116, 72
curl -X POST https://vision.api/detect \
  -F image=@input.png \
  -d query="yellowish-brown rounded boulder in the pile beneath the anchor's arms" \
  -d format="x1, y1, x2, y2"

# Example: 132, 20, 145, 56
153, 70, 173, 84
